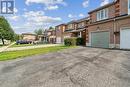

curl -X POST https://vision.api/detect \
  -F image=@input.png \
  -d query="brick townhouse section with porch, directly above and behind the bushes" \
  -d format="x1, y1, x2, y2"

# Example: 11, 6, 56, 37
66, 17, 89, 45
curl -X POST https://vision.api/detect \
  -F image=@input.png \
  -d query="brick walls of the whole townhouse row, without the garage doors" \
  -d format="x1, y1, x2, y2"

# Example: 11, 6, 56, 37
44, 0, 130, 48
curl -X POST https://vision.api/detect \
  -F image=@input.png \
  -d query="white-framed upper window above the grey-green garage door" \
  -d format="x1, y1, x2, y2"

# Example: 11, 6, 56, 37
97, 9, 108, 21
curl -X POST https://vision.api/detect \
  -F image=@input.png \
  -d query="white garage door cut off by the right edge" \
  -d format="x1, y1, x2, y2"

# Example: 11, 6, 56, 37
120, 28, 130, 49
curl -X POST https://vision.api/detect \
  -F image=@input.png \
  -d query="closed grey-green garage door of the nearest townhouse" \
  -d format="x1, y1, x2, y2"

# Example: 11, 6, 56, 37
91, 32, 110, 48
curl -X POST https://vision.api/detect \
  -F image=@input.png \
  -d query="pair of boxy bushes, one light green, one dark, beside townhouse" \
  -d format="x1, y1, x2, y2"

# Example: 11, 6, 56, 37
64, 37, 84, 46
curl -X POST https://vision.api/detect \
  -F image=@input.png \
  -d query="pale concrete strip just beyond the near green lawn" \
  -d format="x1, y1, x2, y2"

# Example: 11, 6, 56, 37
4, 44, 61, 51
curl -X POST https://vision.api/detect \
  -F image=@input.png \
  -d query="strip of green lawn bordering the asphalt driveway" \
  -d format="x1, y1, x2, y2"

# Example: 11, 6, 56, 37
0, 46, 73, 61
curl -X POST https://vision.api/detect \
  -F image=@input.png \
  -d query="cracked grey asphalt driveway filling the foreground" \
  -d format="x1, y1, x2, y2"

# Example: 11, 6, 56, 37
0, 47, 130, 87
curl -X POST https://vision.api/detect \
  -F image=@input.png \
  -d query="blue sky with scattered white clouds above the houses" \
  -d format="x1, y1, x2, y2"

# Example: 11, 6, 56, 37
1, 0, 112, 34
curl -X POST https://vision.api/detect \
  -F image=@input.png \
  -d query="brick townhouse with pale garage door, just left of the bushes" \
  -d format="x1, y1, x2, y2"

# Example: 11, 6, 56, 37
55, 24, 71, 43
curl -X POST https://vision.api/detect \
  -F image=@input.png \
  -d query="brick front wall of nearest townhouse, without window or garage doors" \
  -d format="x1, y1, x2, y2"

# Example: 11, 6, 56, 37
86, 0, 130, 48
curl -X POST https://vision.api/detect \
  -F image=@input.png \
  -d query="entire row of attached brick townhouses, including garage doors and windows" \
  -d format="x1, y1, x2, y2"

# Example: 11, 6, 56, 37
43, 0, 130, 49
